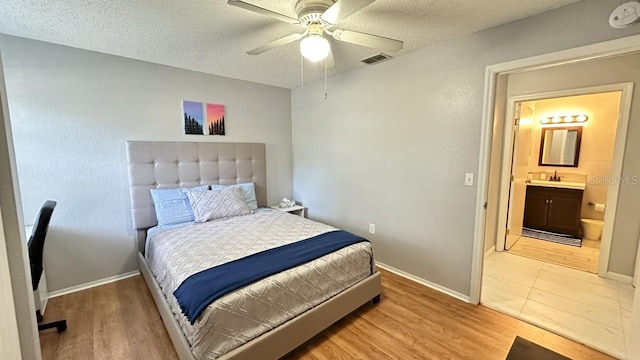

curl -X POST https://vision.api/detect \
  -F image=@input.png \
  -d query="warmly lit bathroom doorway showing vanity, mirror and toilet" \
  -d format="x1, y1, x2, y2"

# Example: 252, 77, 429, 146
496, 86, 626, 276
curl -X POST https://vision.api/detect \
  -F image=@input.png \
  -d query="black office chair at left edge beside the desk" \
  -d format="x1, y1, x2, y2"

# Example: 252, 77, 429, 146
29, 200, 67, 332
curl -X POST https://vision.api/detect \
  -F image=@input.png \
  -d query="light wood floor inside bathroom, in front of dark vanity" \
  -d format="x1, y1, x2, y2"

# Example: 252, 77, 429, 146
509, 236, 600, 273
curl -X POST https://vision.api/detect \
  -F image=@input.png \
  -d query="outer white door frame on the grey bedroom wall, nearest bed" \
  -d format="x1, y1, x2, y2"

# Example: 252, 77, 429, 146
469, 35, 640, 304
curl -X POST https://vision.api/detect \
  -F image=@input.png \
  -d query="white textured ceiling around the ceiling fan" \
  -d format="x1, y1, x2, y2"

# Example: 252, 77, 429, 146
0, 0, 579, 88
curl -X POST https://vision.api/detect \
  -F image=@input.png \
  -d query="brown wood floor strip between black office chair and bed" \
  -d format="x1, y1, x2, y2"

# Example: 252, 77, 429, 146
40, 276, 178, 360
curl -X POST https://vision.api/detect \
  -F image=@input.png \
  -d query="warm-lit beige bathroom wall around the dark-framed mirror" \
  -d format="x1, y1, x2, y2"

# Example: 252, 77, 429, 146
529, 92, 620, 220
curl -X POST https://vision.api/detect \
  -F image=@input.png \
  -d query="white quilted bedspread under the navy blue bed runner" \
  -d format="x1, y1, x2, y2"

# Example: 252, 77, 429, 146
146, 209, 373, 359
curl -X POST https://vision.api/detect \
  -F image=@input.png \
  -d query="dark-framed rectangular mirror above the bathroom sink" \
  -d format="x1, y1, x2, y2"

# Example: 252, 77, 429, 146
538, 126, 582, 167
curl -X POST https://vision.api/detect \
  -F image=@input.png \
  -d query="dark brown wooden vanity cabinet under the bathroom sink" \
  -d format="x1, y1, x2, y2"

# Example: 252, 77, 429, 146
523, 185, 583, 237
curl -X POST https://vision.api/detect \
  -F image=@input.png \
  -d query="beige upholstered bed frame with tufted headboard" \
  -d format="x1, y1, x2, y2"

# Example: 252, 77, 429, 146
127, 141, 382, 360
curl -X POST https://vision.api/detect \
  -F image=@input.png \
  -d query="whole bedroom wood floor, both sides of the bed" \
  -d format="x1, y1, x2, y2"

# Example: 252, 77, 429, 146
40, 271, 612, 360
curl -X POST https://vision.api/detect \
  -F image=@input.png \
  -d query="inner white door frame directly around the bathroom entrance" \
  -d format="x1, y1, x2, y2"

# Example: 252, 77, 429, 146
496, 82, 633, 277
